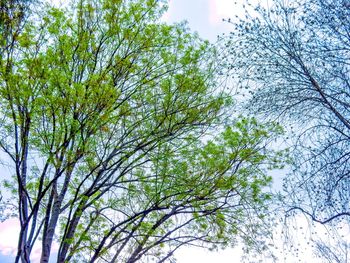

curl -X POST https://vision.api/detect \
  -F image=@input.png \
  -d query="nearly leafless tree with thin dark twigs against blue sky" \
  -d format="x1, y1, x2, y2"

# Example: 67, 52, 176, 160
226, 0, 350, 227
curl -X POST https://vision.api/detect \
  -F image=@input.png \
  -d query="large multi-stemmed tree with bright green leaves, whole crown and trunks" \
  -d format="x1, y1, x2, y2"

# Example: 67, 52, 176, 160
0, 0, 283, 262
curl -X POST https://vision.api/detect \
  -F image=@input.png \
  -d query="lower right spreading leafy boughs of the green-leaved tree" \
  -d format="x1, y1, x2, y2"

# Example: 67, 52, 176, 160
59, 120, 281, 262
